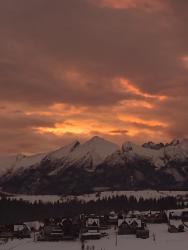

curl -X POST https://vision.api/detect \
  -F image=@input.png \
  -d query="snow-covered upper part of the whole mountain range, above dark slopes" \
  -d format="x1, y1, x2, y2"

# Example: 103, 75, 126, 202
0, 136, 188, 178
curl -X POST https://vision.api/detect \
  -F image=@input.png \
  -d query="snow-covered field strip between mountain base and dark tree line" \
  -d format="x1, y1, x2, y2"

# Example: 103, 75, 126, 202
10, 190, 188, 203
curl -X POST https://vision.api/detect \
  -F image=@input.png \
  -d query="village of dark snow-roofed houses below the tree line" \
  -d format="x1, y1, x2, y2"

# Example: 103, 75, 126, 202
0, 210, 188, 250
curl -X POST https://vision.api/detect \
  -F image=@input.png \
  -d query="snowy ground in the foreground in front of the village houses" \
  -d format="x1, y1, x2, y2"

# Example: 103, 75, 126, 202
0, 224, 188, 250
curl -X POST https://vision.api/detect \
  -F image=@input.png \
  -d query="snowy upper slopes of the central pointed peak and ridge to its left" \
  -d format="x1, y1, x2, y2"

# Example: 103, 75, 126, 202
0, 137, 118, 175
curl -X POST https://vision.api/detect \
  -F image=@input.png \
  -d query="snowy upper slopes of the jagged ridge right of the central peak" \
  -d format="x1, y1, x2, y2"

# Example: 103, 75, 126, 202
107, 139, 188, 169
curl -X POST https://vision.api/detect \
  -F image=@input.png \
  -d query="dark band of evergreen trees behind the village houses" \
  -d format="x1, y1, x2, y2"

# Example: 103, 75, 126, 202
0, 195, 183, 224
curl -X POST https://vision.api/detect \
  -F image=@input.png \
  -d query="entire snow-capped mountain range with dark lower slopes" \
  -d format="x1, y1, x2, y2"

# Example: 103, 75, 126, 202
0, 137, 188, 194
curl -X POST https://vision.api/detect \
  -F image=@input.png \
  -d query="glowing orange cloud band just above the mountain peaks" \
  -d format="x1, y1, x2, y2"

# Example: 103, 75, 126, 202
1, 97, 168, 149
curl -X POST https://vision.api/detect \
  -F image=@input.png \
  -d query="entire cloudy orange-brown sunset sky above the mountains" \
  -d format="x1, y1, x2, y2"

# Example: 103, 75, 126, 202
0, 0, 188, 154
